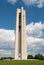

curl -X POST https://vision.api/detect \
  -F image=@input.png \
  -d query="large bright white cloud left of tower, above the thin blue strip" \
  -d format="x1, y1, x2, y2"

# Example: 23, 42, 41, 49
0, 29, 15, 48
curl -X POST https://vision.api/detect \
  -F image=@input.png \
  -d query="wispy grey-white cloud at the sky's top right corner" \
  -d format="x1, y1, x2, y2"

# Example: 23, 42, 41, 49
23, 0, 44, 8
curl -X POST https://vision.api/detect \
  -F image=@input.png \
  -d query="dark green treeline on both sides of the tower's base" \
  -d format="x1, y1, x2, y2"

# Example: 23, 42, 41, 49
0, 54, 44, 60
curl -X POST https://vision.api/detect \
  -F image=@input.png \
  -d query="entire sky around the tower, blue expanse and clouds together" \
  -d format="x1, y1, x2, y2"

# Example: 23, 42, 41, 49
0, 0, 44, 57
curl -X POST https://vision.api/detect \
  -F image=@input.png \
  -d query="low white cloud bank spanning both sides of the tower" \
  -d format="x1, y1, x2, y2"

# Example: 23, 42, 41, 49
0, 22, 44, 57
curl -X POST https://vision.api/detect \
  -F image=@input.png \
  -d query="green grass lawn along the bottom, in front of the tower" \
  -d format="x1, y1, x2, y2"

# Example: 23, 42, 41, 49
0, 60, 44, 65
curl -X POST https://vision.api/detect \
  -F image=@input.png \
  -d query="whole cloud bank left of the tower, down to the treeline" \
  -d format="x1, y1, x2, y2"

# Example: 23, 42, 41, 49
0, 29, 15, 57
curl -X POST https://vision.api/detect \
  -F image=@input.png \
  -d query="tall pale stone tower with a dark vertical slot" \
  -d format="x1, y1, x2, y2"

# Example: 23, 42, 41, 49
15, 7, 27, 60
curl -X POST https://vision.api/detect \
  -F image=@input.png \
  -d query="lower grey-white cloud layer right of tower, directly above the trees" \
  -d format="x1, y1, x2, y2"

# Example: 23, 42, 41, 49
27, 38, 44, 55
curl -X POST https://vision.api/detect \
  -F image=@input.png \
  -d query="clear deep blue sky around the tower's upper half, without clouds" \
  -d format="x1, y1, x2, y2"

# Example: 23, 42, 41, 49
0, 0, 44, 29
